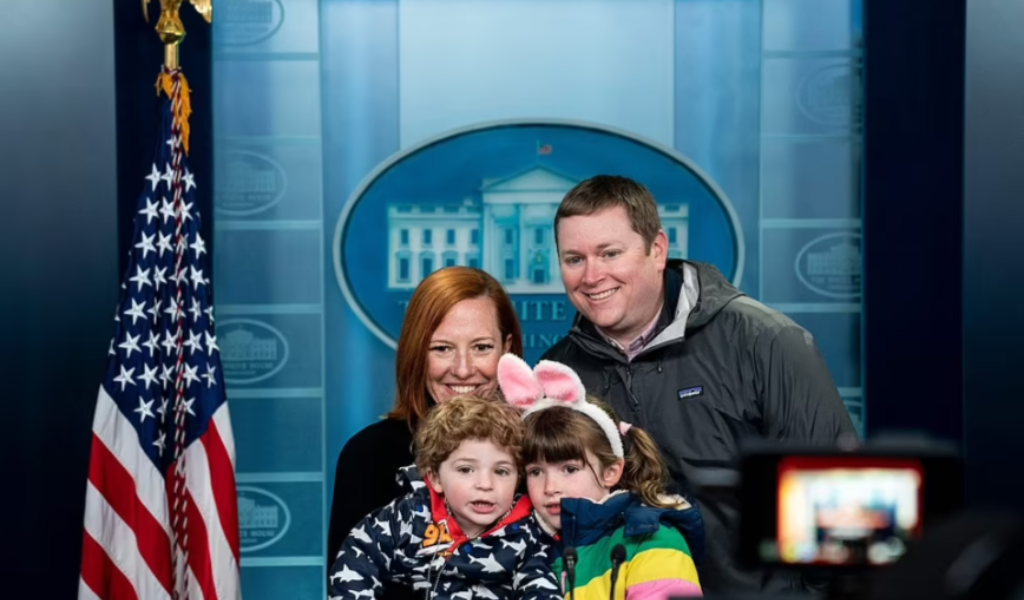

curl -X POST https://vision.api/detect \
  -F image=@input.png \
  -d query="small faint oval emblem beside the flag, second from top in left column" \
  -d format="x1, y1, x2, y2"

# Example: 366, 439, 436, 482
213, 151, 288, 217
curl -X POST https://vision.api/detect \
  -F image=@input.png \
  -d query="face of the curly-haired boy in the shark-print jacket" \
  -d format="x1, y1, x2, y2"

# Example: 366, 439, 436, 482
429, 439, 519, 538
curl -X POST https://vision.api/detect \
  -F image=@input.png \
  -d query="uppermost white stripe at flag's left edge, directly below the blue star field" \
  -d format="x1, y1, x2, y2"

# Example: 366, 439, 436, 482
92, 386, 171, 539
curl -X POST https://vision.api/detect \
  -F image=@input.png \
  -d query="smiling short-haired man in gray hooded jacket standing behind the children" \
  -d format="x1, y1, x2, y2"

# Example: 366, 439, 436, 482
544, 175, 855, 593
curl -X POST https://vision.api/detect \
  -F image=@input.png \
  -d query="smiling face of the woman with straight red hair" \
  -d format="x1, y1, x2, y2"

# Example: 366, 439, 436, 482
427, 296, 512, 403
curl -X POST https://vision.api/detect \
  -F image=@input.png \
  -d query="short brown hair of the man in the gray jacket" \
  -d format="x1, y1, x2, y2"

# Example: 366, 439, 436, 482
555, 175, 662, 253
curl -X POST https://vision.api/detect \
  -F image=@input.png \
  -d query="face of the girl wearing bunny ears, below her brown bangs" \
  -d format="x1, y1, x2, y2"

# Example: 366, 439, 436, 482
526, 451, 623, 529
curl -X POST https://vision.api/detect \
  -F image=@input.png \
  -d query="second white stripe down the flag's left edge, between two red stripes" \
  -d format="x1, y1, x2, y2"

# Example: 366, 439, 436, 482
85, 481, 170, 600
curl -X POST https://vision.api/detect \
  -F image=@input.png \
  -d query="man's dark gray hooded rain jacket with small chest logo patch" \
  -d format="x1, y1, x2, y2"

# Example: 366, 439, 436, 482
544, 260, 855, 593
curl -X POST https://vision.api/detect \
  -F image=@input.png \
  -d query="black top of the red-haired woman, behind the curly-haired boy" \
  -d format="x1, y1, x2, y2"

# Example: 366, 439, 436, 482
327, 419, 415, 600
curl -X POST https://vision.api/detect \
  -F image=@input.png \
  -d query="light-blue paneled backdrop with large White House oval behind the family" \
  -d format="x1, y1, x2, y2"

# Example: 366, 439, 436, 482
207, 0, 864, 600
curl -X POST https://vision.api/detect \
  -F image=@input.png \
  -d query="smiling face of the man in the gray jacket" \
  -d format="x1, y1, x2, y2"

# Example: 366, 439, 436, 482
557, 206, 669, 345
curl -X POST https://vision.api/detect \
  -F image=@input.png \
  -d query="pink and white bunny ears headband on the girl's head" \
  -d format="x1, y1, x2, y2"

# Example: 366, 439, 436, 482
498, 354, 629, 459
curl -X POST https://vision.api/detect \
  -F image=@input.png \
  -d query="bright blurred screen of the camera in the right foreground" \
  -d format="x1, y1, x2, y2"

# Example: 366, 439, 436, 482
765, 457, 924, 565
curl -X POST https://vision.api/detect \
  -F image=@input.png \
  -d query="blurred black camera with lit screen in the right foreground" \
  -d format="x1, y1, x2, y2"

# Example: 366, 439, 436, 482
738, 436, 965, 575
